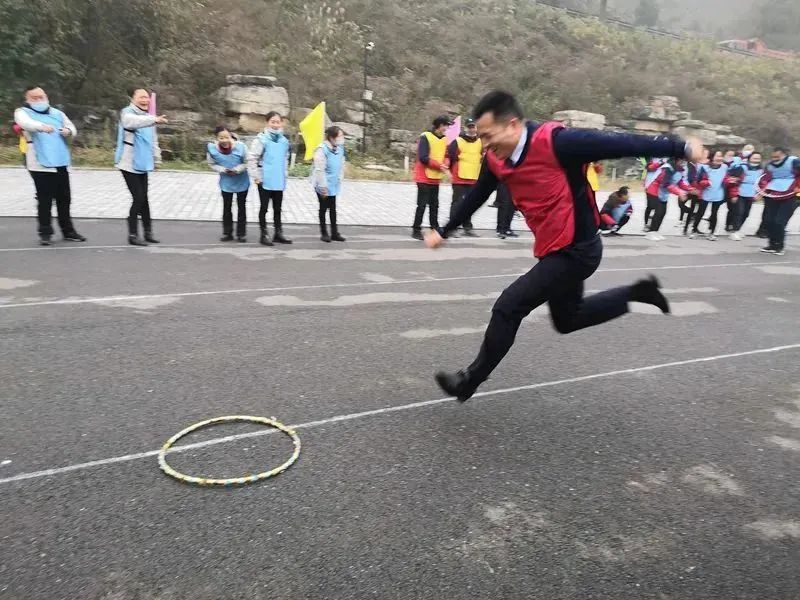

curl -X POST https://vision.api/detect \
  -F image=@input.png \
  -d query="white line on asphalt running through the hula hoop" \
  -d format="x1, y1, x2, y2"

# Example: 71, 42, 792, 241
0, 343, 800, 484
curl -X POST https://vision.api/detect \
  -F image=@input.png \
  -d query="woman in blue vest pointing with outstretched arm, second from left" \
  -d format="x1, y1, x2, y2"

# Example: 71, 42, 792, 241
114, 88, 167, 246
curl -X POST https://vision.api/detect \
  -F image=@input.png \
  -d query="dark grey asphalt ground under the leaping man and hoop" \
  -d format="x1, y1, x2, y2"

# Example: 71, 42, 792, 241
0, 218, 800, 600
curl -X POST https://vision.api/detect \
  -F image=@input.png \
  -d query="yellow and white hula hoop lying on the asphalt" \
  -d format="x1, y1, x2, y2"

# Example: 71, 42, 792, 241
158, 415, 300, 487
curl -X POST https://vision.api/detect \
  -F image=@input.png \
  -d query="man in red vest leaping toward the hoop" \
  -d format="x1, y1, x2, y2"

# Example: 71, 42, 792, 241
425, 91, 702, 402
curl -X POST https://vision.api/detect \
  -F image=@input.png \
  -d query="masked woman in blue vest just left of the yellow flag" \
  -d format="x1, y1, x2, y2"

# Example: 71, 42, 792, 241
247, 111, 292, 246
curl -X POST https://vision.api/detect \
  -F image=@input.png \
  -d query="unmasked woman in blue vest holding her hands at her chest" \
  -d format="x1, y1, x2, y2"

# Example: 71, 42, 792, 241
206, 126, 250, 243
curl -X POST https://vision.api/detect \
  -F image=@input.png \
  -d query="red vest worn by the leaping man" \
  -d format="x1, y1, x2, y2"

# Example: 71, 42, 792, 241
486, 122, 600, 258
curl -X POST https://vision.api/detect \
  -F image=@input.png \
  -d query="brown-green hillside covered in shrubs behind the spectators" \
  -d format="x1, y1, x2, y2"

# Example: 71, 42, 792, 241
0, 0, 800, 147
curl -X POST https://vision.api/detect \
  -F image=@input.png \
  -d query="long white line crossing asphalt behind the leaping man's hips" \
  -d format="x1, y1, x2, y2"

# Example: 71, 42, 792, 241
0, 261, 796, 310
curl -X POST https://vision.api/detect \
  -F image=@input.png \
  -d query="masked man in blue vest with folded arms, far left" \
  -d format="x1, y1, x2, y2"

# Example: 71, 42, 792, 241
14, 86, 86, 246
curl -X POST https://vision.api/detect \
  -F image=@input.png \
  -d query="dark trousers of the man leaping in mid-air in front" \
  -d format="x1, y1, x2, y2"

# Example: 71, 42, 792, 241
469, 236, 630, 383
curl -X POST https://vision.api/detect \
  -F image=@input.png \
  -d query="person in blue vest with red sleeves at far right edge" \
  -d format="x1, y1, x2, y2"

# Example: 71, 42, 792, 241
758, 148, 800, 256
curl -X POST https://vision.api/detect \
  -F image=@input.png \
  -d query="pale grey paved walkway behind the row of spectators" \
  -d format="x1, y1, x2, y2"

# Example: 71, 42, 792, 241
0, 168, 800, 235
